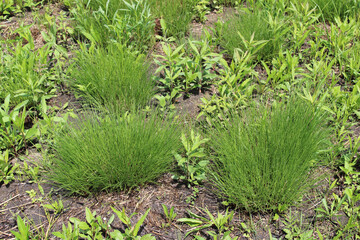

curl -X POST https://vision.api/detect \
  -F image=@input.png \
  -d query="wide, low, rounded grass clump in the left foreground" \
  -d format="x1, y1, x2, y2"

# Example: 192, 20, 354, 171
49, 113, 180, 194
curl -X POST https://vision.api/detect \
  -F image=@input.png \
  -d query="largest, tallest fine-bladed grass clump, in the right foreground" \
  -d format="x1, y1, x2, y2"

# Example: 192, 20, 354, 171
210, 99, 329, 211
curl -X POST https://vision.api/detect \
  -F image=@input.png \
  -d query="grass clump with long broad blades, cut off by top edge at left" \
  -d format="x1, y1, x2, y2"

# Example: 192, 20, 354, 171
71, 0, 155, 51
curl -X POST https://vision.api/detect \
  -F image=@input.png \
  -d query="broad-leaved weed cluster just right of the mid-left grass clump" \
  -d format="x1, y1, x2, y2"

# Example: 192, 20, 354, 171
154, 40, 222, 102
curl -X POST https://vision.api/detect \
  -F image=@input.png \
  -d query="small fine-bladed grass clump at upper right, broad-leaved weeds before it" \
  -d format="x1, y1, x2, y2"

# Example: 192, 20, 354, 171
217, 9, 284, 60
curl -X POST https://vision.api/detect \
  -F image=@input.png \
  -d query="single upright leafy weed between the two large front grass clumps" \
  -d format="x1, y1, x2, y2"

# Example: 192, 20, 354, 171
173, 130, 209, 188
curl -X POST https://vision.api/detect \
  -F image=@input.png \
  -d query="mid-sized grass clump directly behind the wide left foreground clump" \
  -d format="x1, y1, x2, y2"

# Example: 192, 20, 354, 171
71, 45, 154, 111
